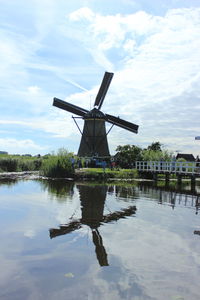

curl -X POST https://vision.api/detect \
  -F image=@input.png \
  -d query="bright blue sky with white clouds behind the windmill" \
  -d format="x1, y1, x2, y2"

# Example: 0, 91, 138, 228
0, 0, 200, 156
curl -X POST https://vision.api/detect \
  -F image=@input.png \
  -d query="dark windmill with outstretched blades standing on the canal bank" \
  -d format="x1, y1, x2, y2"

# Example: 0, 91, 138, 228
53, 72, 138, 157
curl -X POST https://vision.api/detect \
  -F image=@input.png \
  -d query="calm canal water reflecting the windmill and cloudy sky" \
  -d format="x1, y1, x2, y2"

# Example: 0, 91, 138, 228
0, 180, 200, 300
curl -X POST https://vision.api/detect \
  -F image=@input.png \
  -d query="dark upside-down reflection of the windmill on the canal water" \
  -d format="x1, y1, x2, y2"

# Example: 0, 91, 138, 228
49, 185, 136, 266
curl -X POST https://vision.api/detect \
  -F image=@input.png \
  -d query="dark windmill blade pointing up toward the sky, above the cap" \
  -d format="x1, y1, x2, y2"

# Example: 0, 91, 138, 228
94, 72, 114, 109
